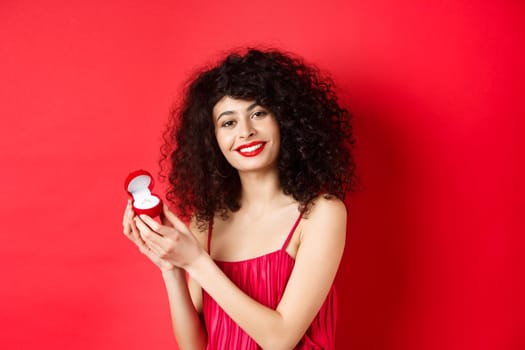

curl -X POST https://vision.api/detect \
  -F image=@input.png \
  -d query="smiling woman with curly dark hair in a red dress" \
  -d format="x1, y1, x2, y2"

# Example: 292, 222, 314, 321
123, 49, 354, 350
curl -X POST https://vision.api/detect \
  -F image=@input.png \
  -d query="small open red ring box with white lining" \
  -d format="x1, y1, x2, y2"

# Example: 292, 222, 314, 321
124, 170, 162, 218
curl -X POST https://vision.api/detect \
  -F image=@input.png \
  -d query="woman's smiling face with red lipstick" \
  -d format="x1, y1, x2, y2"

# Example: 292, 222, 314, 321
212, 96, 280, 172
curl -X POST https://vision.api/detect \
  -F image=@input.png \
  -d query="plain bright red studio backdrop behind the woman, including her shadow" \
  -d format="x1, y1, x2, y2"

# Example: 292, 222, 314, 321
0, 0, 525, 350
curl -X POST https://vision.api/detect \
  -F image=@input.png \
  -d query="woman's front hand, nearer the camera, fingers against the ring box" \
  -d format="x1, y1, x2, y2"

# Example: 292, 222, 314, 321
133, 205, 205, 268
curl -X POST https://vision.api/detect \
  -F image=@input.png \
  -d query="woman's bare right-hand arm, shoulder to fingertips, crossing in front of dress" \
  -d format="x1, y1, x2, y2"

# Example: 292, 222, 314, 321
138, 198, 346, 350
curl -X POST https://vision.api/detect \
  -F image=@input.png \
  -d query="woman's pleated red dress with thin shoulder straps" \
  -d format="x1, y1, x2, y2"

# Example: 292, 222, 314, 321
203, 214, 337, 350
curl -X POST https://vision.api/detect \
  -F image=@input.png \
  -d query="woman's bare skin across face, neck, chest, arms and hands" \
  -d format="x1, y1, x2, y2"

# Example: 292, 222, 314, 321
123, 97, 346, 349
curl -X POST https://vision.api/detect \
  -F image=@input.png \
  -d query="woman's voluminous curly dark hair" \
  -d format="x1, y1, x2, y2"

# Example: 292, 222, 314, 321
160, 48, 355, 224
